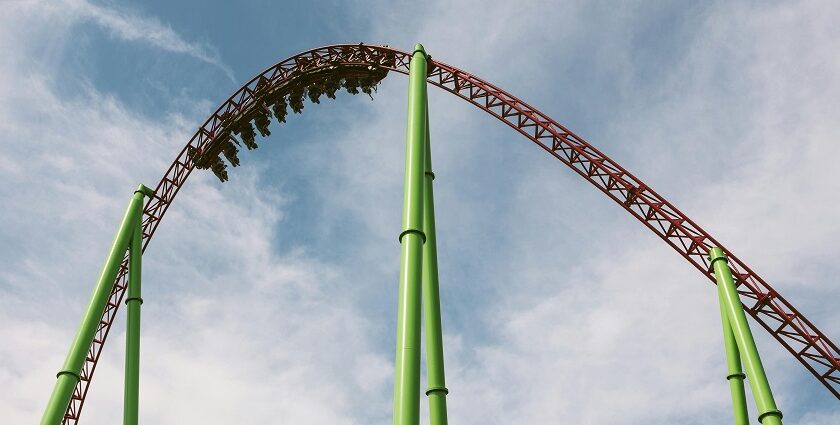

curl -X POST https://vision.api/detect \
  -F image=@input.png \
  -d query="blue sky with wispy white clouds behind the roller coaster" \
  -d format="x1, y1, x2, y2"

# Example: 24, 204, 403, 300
0, 0, 840, 425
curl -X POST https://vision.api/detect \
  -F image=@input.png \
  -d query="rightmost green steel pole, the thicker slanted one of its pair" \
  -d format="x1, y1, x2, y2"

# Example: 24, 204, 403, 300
709, 247, 782, 425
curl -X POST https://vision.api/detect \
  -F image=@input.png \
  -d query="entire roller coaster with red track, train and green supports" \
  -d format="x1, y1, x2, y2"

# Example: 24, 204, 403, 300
41, 44, 840, 425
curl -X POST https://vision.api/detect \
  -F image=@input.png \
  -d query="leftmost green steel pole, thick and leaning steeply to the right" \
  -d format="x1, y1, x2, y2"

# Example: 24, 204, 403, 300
41, 185, 154, 425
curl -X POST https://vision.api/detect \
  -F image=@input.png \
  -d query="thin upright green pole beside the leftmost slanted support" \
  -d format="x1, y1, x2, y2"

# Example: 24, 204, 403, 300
123, 210, 143, 425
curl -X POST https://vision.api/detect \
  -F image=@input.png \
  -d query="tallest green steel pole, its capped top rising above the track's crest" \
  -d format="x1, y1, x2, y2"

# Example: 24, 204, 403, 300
394, 44, 426, 425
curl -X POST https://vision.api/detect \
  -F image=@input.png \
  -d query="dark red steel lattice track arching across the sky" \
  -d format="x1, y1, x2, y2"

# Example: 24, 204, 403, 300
62, 44, 840, 424
